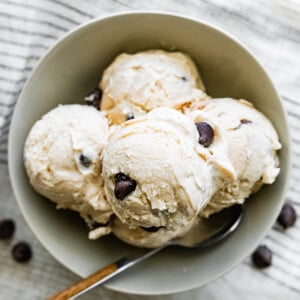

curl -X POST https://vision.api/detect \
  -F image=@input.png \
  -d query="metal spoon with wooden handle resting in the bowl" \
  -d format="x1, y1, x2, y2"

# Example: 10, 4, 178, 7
48, 204, 243, 300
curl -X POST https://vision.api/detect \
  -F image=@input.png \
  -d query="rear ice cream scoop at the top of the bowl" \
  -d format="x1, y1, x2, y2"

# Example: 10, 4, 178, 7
100, 50, 207, 124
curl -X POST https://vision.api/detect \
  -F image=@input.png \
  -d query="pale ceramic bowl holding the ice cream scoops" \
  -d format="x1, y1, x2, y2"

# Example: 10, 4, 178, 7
9, 12, 290, 295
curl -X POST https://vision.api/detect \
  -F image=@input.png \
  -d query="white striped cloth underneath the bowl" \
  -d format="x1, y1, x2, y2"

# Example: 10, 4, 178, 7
0, 0, 300, 300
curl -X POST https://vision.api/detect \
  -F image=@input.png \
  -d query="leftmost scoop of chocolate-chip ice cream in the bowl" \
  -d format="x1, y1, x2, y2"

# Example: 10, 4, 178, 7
24, 104, 112, 230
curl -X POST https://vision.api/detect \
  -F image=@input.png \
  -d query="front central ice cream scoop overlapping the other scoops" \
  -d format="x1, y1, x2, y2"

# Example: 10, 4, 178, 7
103, 108, 213, 232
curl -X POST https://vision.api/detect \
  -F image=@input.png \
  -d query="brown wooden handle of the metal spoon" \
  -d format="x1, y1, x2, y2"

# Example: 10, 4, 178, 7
48, 263, 118, 300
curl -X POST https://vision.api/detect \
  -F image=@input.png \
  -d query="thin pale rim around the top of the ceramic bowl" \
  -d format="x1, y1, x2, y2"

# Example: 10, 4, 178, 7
8, 10, 292, 296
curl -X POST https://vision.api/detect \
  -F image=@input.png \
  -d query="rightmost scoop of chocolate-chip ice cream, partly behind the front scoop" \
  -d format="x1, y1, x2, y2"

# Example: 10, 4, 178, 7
191, 98, 281, 217
